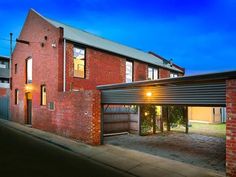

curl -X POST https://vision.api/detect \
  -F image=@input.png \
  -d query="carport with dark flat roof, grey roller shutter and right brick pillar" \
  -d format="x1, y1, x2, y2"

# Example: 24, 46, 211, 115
97, 71, 236, 176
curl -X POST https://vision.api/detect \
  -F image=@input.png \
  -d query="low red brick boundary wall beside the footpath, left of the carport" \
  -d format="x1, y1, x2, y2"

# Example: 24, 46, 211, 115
32, 90, 101, 145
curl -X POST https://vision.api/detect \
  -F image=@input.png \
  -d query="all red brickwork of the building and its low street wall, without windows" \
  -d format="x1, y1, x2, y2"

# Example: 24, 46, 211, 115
10, 11, 182, 145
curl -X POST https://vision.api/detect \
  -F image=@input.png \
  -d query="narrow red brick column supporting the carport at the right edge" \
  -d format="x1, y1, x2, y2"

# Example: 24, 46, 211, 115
226, 79, 236, 177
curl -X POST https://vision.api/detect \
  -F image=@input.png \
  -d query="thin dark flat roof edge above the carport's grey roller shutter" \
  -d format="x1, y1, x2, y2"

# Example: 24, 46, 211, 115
97, 70, 236, 90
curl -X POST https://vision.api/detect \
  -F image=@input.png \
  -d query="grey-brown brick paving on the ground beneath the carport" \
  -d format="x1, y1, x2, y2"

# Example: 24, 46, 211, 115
105, 132, 225, 172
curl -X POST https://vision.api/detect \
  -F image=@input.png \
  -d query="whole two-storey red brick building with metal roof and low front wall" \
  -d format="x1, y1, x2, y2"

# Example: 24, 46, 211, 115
10, 10, 184, 144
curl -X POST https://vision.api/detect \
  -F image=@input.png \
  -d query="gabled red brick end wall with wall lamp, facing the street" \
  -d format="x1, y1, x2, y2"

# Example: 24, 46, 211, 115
11, 11, 62, 124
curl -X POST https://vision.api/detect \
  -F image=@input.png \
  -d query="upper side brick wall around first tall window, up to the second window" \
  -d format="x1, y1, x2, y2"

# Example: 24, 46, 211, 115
66, 43, 125, 90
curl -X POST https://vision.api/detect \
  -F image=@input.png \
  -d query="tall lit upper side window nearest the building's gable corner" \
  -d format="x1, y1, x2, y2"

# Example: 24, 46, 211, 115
73, 47, 85, 78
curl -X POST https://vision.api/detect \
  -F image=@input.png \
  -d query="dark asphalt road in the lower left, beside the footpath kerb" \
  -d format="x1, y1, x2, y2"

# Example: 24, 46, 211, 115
0, 124, 133, 177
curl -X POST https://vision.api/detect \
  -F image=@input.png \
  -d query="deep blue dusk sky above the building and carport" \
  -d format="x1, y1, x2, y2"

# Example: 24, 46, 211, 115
0, 0, 236, 75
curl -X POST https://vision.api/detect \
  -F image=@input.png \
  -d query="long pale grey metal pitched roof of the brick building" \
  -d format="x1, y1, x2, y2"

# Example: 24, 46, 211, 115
33, 10, 182, 72
